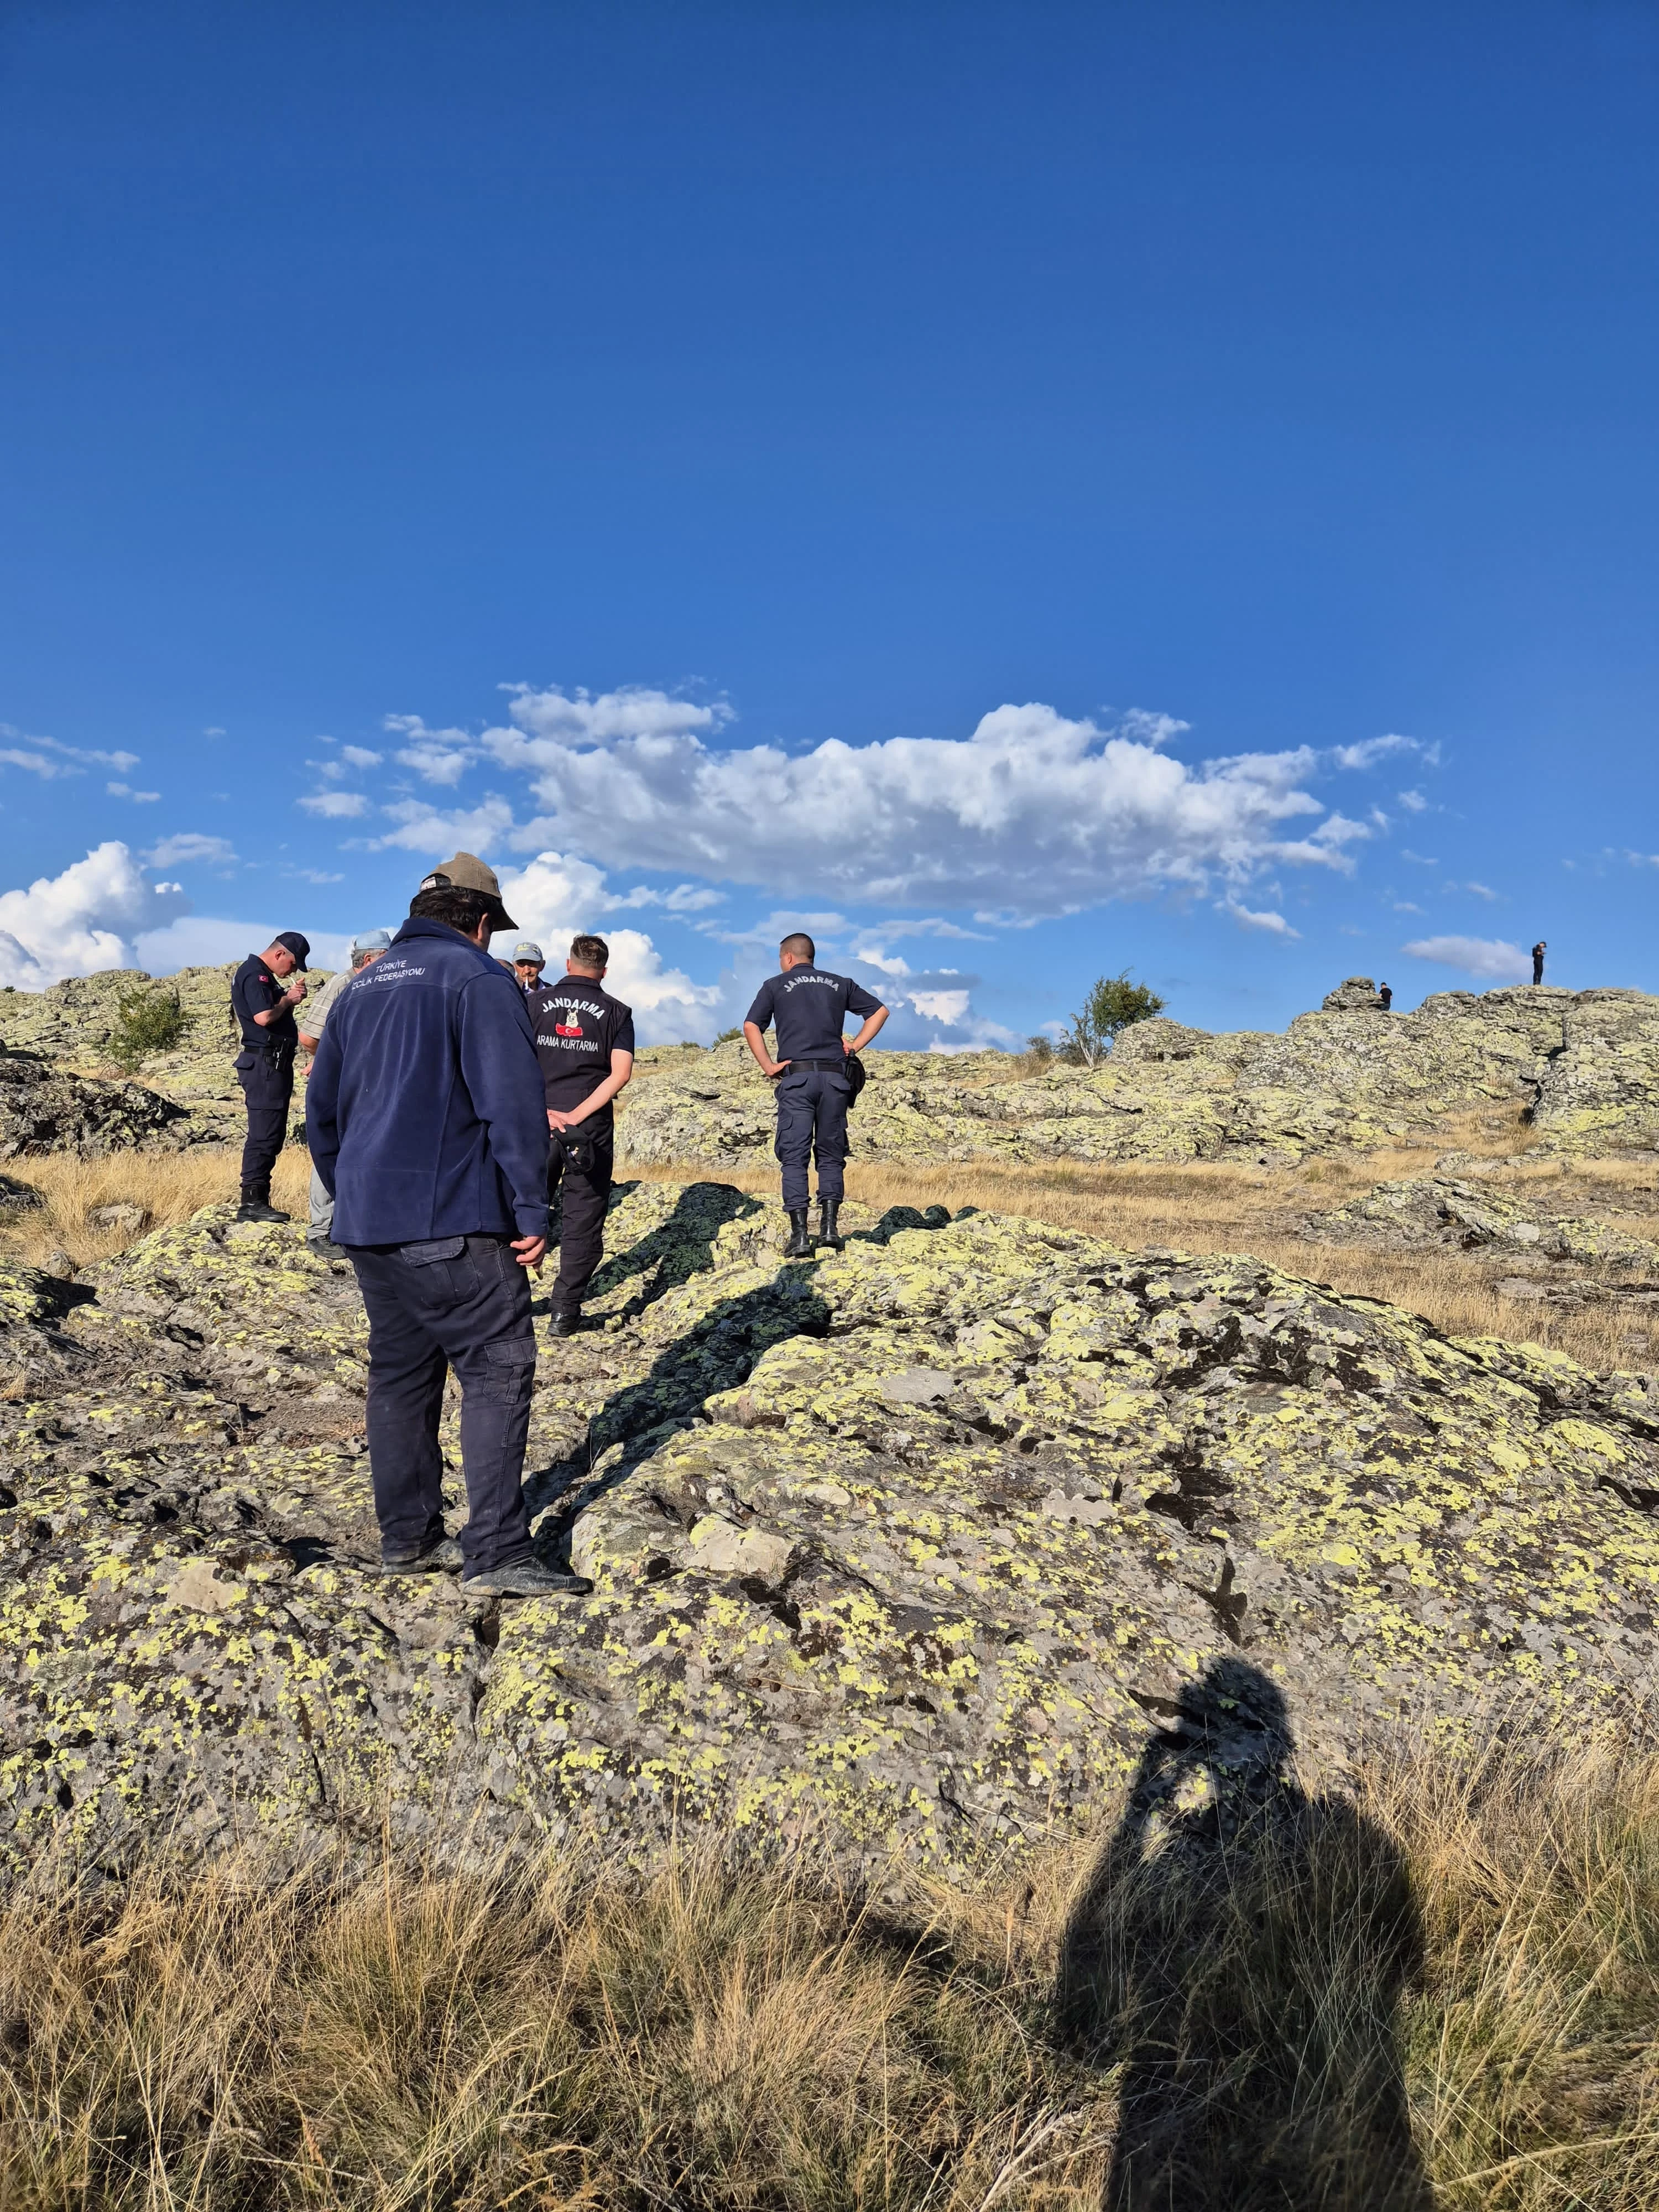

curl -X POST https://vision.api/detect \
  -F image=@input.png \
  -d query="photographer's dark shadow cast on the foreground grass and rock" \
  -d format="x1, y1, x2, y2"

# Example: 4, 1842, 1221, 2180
1055, 1659, 1433, 2212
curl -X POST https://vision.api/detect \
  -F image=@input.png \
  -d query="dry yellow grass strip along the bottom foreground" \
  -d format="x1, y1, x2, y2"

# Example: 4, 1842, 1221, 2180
0, 1745, 1659, 2212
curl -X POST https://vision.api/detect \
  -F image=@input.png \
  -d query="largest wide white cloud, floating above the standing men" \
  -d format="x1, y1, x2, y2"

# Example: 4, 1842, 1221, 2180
480, 692, 1367, 916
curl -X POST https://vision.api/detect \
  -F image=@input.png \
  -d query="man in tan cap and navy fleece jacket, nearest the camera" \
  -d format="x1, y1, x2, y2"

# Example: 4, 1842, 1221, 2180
305, 852, 588, 1597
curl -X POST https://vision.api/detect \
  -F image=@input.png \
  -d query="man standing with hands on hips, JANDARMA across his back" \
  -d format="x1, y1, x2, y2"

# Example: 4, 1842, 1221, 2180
743, 931, 887, 1259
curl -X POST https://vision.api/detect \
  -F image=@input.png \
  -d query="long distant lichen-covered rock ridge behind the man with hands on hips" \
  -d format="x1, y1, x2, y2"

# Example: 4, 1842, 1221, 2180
622, 978, 1659, 1166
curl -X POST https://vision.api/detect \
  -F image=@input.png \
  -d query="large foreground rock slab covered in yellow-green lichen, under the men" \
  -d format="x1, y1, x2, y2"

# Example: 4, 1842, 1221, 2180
0, 1183, 1659, 1863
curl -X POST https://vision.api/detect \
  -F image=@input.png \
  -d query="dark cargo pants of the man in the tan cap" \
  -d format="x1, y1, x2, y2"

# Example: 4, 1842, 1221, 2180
347, 1237, 535, 1575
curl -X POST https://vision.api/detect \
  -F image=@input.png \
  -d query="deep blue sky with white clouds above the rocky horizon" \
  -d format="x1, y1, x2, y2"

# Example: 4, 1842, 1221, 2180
0, 0, 1659, 1046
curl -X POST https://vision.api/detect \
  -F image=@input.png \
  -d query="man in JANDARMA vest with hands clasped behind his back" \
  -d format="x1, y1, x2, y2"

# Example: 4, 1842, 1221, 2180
533, 936, 633, 1336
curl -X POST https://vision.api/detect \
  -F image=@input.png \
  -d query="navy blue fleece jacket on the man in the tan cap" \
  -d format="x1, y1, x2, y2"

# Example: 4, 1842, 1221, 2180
305, 922, 549, 1245
